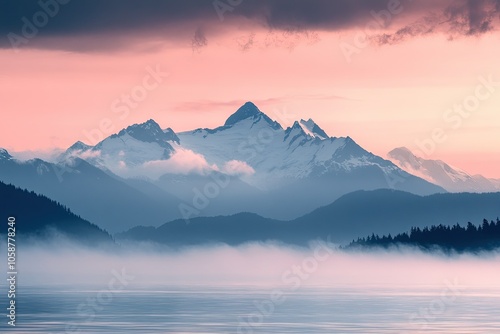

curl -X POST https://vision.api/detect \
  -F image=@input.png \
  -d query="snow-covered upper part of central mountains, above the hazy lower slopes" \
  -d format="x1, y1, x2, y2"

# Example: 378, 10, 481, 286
49, 102, 418, 189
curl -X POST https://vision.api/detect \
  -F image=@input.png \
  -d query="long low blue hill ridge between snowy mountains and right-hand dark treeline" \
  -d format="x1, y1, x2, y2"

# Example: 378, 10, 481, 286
116, 190, 500, 246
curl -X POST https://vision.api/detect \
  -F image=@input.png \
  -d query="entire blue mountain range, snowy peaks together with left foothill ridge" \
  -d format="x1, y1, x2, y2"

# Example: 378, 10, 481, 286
0, 102, 493, 233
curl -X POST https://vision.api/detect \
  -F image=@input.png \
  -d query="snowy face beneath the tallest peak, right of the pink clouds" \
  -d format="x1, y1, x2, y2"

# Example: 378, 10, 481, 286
179, 108, 382, 189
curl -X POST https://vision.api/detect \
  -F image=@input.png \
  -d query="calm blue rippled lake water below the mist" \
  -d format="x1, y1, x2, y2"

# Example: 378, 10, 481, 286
7, 284, 500, 334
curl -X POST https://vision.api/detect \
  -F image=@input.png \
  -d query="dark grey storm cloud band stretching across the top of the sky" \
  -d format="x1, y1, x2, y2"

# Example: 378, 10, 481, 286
0, 0, 500, 51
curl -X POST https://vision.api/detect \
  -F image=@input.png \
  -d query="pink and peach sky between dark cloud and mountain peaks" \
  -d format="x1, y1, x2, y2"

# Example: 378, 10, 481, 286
0, 1, 500, 178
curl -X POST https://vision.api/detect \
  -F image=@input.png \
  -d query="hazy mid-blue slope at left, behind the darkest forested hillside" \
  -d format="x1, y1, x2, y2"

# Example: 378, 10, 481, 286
0, 153, 180, 232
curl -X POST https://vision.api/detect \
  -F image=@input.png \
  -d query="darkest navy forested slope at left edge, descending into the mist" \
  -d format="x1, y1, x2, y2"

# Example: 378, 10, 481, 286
0, 182, 113, 245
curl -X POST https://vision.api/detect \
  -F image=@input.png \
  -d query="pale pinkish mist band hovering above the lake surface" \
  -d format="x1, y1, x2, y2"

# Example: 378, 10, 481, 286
9, 240, 500, 287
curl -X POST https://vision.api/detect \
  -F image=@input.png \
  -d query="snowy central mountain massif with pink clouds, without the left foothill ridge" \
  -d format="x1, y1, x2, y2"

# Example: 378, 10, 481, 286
58, 102, 445, 226
